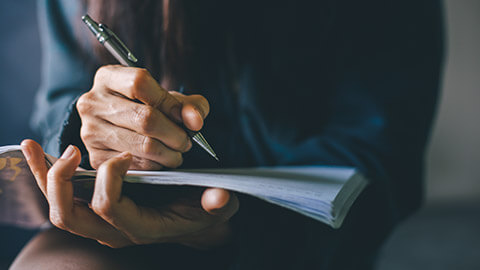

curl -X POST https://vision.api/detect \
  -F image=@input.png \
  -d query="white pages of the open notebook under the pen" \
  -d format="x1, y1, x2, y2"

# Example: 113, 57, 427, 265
77, 166, 363, 228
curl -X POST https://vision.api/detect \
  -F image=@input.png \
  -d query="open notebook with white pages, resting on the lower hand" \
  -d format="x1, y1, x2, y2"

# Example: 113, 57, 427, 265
0, 146, 368, 228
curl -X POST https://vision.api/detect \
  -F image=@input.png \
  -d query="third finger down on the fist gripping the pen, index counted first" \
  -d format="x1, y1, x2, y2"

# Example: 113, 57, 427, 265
81, 120, 183, 168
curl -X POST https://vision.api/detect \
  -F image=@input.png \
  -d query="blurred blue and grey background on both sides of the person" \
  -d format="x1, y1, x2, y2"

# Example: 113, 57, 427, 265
0, 0, 480, 270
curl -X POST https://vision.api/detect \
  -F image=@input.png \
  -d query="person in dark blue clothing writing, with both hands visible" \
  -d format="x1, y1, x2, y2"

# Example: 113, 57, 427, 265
12, 0, 443, 269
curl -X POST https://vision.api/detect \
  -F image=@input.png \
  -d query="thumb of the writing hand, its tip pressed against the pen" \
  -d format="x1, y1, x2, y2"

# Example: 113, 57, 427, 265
170, 91, 210, 131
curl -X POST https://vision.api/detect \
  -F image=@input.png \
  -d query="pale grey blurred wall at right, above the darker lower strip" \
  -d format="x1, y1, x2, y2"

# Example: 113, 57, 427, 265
427, 0, 480, 202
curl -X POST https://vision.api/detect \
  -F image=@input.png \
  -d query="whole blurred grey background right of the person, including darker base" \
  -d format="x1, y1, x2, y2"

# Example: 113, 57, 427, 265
377, 0, 480, 270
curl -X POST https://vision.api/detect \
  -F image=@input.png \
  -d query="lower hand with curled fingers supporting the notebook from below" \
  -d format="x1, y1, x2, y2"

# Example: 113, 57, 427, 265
22, 140, 239, 249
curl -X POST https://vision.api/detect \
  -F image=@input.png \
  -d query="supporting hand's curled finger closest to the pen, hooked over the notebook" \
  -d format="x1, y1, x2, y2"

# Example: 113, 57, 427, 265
92, 155, 214, 244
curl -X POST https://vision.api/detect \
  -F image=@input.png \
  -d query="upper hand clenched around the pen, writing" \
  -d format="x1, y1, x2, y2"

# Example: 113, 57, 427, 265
77, 66, 210, 170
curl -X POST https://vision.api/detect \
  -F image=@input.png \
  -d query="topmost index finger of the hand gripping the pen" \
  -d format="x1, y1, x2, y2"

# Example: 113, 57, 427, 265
94, 65, 181, 121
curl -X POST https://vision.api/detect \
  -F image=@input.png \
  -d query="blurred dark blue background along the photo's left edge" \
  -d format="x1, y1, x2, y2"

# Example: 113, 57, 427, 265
0, 0, 41, 269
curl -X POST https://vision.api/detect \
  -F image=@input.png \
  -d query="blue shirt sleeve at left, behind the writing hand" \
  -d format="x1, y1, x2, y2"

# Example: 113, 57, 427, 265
31, 0, 94, 156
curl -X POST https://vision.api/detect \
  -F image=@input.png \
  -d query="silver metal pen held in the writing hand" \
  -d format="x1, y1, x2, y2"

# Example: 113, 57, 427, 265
82, 15, 218, 161
